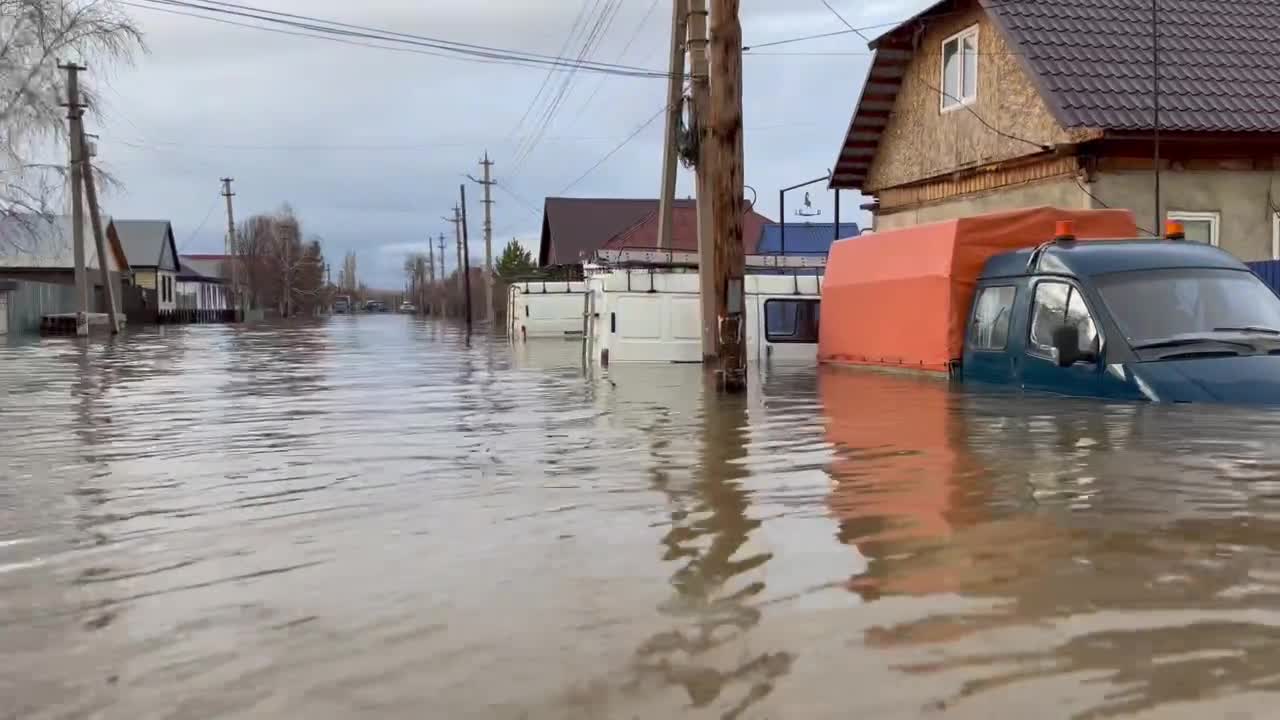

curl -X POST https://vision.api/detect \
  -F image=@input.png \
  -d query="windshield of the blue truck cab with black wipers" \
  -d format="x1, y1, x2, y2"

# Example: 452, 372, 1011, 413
1097, 268, 1280, 345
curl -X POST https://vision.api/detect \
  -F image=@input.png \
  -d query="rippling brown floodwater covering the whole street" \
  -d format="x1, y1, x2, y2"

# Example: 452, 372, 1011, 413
0, 315, 1280, 720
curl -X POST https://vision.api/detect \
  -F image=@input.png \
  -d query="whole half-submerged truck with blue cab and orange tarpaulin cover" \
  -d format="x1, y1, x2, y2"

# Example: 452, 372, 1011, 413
818, 208, 1280, 404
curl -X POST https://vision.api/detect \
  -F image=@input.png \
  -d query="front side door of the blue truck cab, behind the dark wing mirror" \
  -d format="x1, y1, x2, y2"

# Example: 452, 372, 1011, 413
1021, 279, 1103, 397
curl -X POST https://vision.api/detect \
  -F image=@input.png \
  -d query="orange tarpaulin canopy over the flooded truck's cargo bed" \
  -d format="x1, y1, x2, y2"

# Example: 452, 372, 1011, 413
818, 202, 1138, 373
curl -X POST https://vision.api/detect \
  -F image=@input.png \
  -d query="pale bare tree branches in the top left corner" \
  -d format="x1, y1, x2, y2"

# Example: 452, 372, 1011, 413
0, 0, 143, 226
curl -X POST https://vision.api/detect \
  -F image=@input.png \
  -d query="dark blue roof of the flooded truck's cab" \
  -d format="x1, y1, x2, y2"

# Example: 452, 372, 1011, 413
982, 240, 1248, 278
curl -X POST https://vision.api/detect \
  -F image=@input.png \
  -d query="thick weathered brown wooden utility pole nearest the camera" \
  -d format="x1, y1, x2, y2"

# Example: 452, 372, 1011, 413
710, 0, 746, 392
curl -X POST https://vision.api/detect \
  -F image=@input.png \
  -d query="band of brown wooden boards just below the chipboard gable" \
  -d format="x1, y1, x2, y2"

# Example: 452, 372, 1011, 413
873, 178, 1096, 231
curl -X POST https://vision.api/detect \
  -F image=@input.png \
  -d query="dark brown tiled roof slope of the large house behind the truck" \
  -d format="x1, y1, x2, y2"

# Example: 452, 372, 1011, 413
982, 0, 1280, 132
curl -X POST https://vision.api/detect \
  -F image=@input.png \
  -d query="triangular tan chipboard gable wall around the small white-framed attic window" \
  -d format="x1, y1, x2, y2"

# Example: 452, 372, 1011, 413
863, 0, 1070, 193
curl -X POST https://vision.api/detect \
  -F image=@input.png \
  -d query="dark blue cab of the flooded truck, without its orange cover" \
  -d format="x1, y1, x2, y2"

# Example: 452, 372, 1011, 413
954, 240, 1280, 404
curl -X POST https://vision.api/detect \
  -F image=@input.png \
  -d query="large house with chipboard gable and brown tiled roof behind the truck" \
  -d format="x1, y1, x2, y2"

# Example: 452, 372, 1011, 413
831, 0, 1280, 260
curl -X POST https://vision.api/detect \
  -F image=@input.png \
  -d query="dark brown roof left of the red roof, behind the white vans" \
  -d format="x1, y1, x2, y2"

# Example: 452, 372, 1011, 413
538, 197, 692, 266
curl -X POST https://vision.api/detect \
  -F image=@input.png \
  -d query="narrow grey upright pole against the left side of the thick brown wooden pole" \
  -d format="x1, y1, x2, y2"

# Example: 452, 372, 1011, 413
689, 0, 717, 363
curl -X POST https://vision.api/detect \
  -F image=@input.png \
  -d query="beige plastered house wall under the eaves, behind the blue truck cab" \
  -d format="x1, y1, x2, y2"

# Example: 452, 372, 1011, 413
1092, 170, 1280, 263
